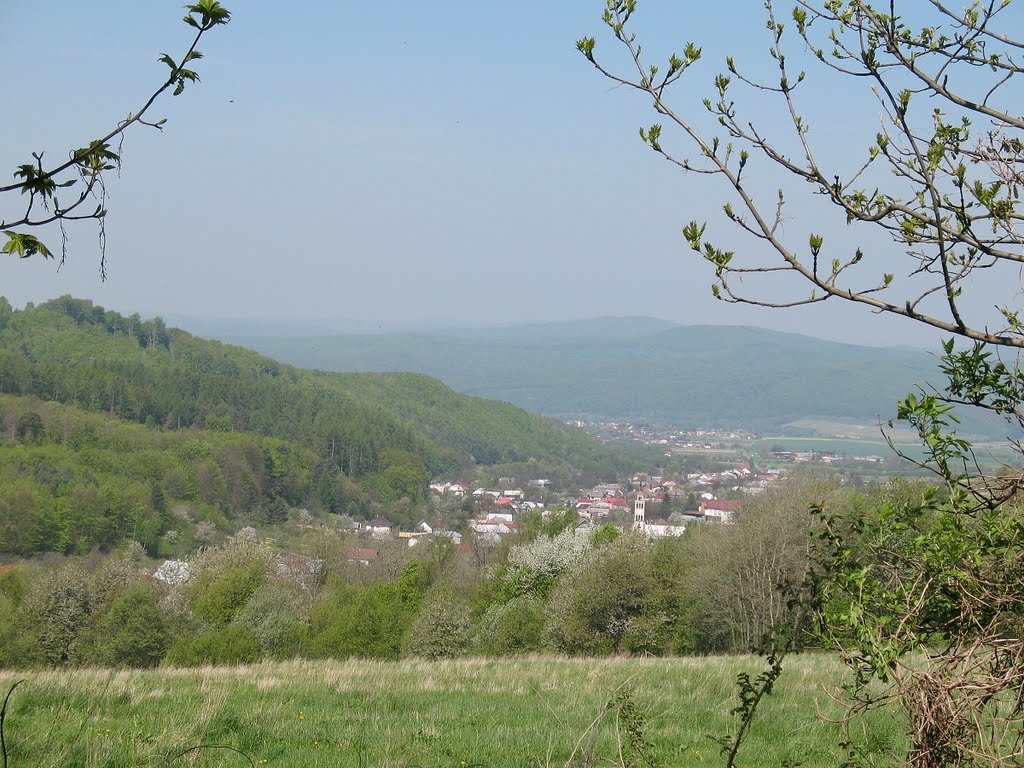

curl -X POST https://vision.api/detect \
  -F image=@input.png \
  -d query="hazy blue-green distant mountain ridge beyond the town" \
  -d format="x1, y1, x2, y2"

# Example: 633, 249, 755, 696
222, 317, 958, 431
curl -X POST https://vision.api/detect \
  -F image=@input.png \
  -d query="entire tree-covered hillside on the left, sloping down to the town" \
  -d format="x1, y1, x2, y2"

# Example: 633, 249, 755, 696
0, 297, 623, 554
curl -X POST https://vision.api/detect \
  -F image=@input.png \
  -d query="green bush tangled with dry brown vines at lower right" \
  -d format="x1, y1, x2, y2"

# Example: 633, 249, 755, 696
815, 450, 1024, 765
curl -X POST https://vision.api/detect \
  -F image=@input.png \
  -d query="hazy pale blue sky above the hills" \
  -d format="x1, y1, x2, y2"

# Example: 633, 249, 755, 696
0, 0, 1011, 343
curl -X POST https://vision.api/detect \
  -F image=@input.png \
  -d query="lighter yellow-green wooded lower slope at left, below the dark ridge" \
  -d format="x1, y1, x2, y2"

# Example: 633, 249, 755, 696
0, 395, 314, 555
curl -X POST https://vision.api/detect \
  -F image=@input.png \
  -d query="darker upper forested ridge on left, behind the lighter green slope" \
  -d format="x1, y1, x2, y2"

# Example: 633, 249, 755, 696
0, 297, 618, 478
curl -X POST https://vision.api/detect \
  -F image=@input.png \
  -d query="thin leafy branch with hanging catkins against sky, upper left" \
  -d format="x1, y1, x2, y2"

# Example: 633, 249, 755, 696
0, 0, 231, 280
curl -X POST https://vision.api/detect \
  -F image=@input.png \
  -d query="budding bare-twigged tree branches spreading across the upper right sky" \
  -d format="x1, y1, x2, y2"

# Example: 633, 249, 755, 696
577, 0, 1024, 347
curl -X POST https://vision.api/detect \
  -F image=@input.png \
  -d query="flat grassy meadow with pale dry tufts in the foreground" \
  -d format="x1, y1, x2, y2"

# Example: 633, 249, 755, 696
0, 655, 901, 768
